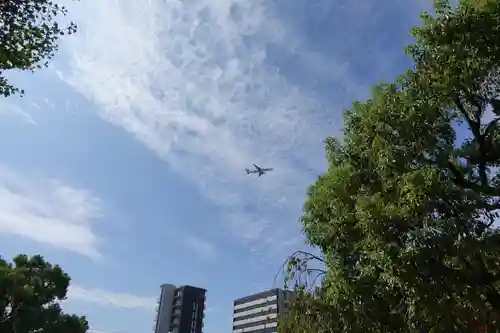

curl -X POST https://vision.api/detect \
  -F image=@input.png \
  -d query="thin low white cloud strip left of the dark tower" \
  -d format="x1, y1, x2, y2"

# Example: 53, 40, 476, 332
67, 285, 157, 310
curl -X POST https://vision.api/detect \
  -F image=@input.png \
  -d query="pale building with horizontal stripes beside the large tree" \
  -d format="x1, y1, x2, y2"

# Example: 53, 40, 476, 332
233, 288, 292, 333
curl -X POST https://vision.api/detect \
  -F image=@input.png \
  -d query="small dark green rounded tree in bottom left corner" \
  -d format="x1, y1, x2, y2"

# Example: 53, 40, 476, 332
0, 255, 89, 333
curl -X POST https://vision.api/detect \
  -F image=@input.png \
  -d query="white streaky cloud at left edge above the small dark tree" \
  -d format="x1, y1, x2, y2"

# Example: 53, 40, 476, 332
0, 165, 102, 260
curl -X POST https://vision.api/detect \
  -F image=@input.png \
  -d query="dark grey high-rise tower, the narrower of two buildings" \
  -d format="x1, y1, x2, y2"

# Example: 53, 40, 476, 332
154, 284, 206, 333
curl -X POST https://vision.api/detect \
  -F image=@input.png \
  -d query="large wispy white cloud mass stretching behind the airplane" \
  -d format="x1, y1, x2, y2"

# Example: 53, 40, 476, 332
54, 0, 428, 256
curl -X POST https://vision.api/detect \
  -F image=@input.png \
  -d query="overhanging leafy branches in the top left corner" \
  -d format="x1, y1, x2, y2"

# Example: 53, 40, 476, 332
0, 0, 76, 97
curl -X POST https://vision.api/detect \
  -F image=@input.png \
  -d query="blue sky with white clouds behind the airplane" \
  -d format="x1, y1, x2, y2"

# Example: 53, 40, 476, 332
0, 0, 428, 333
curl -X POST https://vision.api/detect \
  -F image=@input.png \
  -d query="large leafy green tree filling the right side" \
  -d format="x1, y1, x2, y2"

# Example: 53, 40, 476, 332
280, 0, 500, 333
